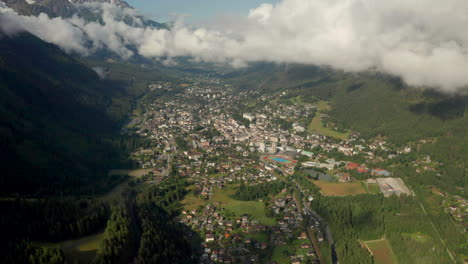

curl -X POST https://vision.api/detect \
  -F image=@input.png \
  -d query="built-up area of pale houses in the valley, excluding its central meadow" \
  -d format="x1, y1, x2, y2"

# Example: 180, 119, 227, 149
123, 72, 454, 264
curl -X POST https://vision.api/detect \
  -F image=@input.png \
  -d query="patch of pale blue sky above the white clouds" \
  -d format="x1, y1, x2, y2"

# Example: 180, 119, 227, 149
127, 0, 279, 22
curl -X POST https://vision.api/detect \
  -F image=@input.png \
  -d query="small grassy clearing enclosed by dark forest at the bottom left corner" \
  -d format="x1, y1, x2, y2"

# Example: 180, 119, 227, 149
59, 233, 104, 263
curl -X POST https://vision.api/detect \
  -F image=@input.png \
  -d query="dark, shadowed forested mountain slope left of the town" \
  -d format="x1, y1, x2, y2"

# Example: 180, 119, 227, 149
0, 33, 132, 194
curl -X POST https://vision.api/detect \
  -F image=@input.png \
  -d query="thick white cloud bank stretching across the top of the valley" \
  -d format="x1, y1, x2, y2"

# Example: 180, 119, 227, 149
0, 0, 468, 92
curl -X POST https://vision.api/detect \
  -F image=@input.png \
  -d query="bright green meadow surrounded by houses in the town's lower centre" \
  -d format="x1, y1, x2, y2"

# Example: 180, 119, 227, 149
212, 187, 276, 225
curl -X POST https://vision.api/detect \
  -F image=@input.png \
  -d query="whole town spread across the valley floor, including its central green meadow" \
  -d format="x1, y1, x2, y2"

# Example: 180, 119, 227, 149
122, 77, 466, 264
